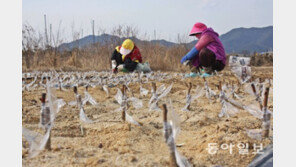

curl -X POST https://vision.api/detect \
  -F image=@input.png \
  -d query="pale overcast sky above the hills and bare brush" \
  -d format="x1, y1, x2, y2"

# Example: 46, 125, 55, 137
22, 0, 273, 41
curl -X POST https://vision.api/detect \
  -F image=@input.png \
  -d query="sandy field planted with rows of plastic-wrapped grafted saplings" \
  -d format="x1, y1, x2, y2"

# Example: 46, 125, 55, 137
22, 63, 273, 167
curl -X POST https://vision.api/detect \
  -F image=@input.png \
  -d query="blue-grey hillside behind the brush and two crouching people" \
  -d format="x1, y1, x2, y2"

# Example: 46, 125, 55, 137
59, 26, 273, 53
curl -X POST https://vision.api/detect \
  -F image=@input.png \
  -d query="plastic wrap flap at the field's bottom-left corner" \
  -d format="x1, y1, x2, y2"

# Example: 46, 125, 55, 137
22, 127, 51, 158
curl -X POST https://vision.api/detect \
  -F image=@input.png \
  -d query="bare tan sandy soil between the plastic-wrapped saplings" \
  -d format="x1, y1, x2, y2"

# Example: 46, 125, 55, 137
22, 67, 273, 167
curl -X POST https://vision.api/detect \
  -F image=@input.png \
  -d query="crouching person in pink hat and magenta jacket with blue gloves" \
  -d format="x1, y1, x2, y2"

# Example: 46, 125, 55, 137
181, 23, 226, 76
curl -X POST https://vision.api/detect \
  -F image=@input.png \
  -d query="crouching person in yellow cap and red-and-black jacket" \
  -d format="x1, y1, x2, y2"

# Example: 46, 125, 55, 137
111, 39, 142, 73
